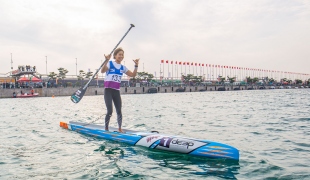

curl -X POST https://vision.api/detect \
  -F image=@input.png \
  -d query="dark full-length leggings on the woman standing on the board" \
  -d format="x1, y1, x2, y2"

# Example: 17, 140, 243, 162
104, 88, 123, 129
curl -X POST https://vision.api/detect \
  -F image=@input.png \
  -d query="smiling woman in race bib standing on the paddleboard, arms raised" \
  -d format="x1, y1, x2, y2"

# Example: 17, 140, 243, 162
101, 48, 139, 132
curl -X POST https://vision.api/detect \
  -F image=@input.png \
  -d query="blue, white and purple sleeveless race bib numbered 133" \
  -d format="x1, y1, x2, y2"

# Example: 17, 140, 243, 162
104, 61, 125, 90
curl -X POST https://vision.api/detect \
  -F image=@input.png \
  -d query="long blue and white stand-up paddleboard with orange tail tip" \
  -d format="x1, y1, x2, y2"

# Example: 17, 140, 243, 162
60, 121, 239, 160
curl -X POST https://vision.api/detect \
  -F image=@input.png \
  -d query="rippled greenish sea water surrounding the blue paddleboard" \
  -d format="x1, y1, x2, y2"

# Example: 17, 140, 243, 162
0, 89, 310, 179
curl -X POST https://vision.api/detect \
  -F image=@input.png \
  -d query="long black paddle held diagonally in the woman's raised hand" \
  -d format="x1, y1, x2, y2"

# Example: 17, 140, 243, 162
71, 24, 135, 103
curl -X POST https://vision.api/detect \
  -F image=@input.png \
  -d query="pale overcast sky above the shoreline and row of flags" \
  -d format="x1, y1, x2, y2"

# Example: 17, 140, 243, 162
0, 0, 310, 76
